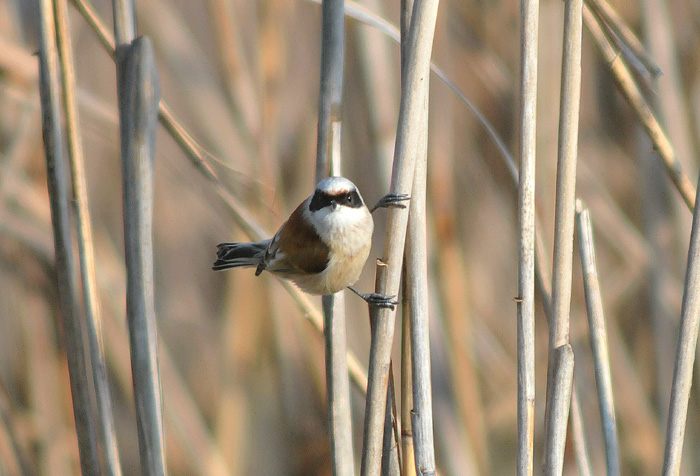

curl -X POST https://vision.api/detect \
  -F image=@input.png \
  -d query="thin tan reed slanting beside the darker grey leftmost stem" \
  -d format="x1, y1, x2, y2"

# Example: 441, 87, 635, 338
54, 0, 122, 476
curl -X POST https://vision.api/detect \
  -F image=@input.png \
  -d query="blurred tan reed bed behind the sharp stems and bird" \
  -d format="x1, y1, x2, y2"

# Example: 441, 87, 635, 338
0, 0, 700, 476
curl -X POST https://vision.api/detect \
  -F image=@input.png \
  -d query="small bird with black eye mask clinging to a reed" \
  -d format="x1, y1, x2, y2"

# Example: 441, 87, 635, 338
212, 177, 410, 309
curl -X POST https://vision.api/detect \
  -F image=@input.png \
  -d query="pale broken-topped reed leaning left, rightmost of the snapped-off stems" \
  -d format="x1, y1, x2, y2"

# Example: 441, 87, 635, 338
576, 200, 620, 476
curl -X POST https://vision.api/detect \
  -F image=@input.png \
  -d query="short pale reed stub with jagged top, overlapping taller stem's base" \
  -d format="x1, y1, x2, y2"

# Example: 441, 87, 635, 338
542, 344, 574, 476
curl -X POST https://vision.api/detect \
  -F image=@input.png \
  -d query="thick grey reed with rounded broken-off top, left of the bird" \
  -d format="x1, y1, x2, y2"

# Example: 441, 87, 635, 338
119, 37, 167, 476
